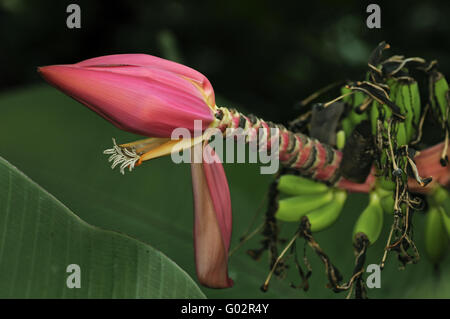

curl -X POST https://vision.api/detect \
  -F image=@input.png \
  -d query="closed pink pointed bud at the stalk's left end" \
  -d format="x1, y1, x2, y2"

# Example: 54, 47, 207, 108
37, 54, 215, 137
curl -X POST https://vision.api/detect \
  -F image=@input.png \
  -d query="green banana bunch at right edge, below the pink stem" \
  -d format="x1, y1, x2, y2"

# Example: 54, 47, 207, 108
425, 186, 450, 264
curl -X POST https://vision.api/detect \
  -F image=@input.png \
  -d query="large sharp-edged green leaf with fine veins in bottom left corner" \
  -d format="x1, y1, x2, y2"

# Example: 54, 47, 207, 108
0, 157, 204, 298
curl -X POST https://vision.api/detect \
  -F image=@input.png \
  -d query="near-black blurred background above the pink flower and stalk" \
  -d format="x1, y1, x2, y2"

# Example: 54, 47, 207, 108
0, 0, 450, 122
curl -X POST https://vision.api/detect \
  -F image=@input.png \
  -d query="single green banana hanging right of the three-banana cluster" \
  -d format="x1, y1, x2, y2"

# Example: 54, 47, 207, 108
353, 192, 383, 244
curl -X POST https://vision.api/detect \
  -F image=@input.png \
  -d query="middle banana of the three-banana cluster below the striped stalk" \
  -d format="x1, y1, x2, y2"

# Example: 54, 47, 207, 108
275, 189, 333, 222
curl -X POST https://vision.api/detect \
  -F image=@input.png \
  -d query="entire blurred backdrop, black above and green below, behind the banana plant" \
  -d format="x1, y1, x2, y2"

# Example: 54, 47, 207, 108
0, 0, 450, 298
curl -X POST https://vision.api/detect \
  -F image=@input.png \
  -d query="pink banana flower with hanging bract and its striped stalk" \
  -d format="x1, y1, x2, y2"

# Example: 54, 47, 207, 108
38, 54, 450, 288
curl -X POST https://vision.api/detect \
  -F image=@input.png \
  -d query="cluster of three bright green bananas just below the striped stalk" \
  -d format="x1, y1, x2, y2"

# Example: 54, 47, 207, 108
275, 175, 347, 232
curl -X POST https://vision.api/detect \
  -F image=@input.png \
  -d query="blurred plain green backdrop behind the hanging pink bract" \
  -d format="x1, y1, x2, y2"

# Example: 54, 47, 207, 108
0, 86, 450, 298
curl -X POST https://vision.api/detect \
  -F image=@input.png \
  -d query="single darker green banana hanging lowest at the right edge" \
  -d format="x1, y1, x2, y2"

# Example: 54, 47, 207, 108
425, 206, 449, 264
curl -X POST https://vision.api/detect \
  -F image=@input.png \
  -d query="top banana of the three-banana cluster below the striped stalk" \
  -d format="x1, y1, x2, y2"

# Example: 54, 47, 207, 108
278, 175, 329, 195
